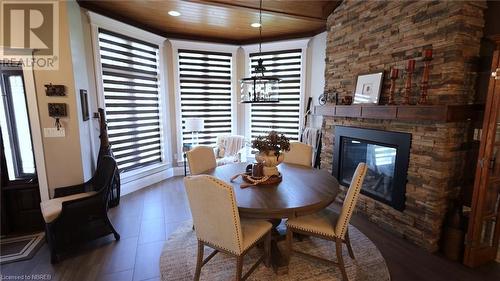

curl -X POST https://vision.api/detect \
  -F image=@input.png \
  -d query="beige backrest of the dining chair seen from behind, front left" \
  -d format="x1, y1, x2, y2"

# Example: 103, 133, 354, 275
184, 175, 243, 255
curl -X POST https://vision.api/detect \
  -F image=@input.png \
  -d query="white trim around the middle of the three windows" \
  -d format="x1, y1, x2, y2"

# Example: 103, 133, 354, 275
169, 40, 239, 165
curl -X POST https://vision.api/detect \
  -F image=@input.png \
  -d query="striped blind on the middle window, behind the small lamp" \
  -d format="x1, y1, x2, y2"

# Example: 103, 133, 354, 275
178, 49, 232, 145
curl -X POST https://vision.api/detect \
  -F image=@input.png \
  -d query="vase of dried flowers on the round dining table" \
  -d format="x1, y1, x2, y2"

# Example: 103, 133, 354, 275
252, 131, 290, 176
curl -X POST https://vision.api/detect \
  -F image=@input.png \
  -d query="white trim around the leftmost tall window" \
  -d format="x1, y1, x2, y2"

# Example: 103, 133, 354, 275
87, 11, 172, 184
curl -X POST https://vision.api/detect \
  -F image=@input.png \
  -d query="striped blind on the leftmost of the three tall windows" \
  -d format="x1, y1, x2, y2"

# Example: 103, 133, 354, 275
99, 28, 162, 171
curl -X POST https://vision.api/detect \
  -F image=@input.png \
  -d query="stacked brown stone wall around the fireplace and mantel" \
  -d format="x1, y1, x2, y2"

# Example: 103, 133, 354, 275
321, 0, 486, 251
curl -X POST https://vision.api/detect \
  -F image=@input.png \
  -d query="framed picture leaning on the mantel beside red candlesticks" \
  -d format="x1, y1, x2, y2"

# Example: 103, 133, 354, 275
353, 71, 384, 104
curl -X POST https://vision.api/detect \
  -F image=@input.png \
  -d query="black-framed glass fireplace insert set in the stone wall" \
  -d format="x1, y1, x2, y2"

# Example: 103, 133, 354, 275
332, 126, 411, 211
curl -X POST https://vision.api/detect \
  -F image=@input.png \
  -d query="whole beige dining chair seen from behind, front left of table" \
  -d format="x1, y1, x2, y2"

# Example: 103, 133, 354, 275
184, 175, 272, 280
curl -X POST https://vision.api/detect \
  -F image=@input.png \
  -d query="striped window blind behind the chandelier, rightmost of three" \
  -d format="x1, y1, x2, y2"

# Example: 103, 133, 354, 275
250, 49, 302, 140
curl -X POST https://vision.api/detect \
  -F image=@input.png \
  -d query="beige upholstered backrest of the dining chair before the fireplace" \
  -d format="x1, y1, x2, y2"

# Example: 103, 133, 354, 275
335, 163, 368, 239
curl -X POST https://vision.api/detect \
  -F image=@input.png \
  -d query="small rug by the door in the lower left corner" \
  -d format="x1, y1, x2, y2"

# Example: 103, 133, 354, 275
0, 232, 45, 264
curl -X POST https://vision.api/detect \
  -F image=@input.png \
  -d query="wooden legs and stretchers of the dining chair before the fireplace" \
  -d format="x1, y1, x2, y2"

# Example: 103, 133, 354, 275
286, 226, 355, 281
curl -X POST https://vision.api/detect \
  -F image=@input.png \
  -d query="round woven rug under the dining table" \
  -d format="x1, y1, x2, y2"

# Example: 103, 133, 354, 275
160, 222, 390, 281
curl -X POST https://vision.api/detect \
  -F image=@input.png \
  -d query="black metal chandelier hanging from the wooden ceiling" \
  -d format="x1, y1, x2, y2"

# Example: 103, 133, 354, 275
240, 0, 280, 103
